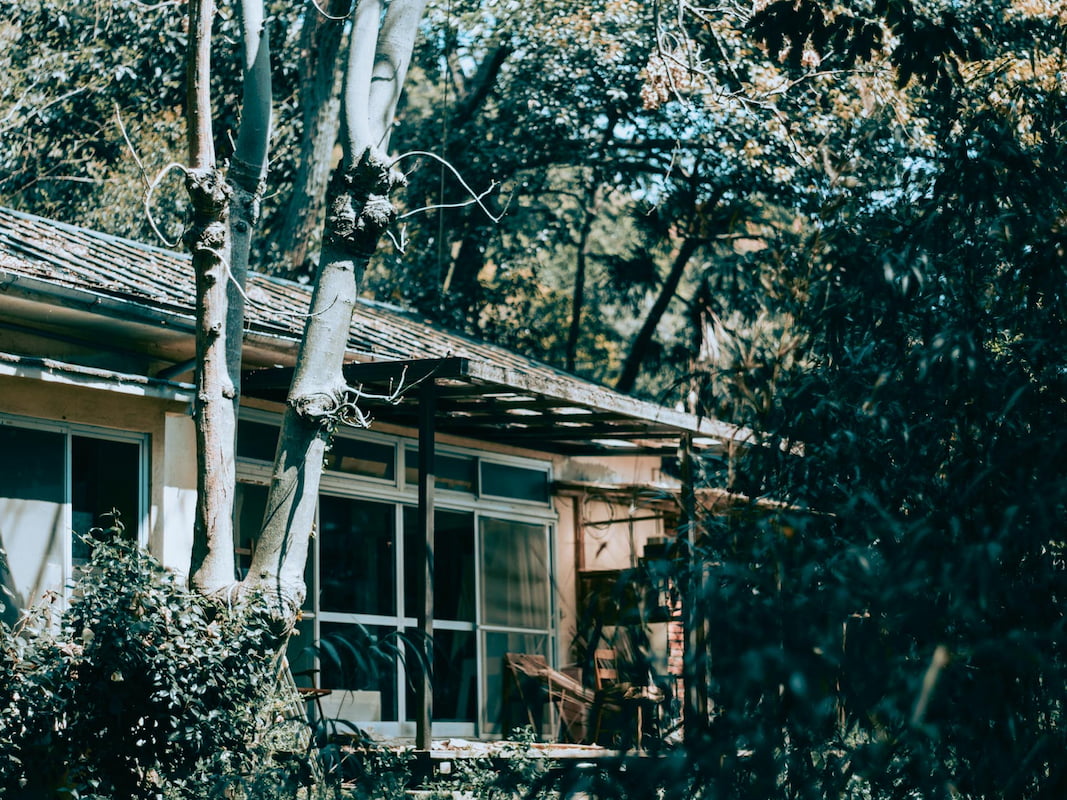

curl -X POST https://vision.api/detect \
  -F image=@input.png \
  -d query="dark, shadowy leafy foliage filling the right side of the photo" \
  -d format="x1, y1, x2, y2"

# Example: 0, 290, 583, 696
674, 3, 1067, 798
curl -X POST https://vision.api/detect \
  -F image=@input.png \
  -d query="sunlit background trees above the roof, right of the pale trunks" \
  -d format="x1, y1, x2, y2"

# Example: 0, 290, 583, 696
372, 0, 891, 402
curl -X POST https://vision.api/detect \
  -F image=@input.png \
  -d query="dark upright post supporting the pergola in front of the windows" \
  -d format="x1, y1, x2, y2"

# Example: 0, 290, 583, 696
411, 378, 437, 752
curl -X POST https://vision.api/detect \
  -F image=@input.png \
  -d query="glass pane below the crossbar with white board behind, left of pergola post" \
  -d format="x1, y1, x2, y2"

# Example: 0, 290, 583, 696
317, 622, 399, 722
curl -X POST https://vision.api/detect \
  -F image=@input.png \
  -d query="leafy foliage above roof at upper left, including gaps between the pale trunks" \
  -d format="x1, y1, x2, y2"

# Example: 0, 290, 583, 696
0, 0, 314, 242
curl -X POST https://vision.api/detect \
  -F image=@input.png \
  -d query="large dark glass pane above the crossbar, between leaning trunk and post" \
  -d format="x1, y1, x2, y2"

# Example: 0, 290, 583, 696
319, 495, 396, 615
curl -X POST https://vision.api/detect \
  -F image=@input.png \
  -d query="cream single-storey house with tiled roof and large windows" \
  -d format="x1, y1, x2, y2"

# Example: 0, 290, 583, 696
0, 209, 748, 737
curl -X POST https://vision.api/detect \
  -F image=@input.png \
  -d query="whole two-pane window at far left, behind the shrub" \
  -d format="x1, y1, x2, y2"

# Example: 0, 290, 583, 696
0, 418, 147, 619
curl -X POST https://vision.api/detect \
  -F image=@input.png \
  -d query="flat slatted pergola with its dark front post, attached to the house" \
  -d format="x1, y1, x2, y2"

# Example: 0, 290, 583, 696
242, 356, 748, 751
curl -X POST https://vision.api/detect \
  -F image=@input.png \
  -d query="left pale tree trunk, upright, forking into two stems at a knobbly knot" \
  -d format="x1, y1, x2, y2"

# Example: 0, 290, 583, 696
186, 0, 271, 594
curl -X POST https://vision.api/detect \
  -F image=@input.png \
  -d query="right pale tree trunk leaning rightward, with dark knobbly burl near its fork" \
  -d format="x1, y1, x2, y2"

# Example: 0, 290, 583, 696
245, 0, 426, 625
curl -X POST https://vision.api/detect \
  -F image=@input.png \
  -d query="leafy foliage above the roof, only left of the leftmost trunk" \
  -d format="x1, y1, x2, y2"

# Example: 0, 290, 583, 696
0, 0, 185, 236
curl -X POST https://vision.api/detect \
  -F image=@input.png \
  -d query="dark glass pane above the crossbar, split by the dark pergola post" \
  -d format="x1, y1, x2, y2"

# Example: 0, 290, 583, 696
404, 506, 475, 622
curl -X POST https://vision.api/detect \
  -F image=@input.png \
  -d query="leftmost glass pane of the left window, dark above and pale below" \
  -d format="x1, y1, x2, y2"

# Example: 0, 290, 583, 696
0, 426, 67, 622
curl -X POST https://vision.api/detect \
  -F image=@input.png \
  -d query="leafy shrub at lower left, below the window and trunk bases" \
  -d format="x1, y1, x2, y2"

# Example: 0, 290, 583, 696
0, 542, 324, 799
